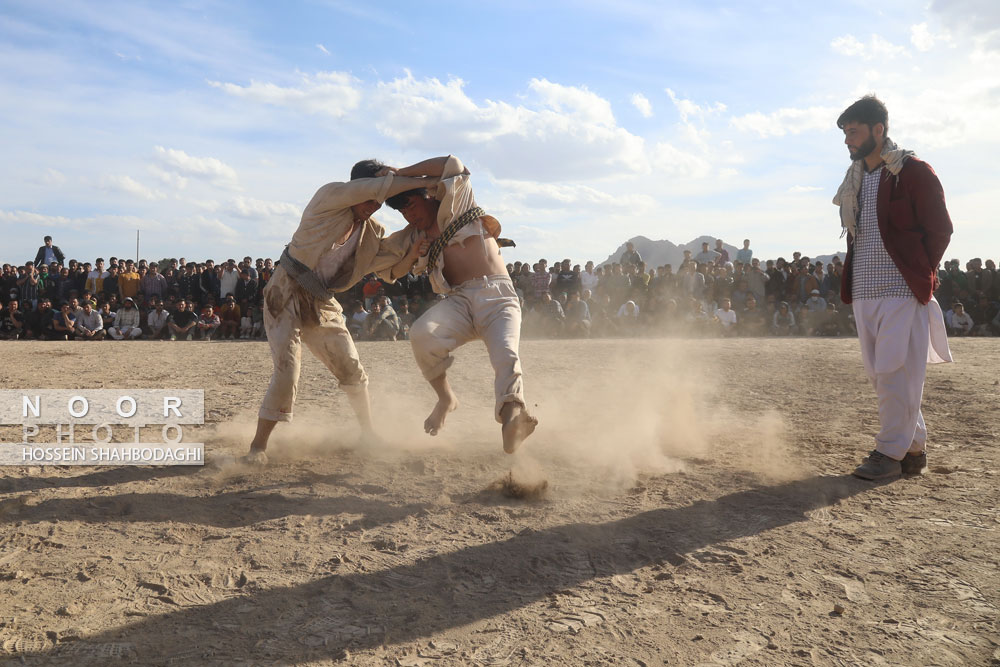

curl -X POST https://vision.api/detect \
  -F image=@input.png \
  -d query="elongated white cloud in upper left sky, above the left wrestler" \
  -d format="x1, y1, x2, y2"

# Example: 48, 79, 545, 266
208, 71, 361, 118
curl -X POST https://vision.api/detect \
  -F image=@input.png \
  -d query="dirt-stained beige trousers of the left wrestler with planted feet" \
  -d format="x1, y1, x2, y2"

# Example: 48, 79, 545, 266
257, 265, 368, 421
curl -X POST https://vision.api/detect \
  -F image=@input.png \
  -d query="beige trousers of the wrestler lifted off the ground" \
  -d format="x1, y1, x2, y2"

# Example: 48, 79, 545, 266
410, 275, 525, 422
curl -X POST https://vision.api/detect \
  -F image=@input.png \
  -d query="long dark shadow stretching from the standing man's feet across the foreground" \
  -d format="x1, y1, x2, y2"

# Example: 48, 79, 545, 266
11, 477, 873, 664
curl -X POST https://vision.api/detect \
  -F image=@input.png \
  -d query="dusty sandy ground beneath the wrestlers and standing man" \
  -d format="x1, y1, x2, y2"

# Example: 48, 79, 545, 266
0, 339, 1000, 666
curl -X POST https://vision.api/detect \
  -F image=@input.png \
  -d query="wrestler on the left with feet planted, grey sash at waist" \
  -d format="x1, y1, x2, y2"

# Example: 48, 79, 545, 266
242, 160, 428, 465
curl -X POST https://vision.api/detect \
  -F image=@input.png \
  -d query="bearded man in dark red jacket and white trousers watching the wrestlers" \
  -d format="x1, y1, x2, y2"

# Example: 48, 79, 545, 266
834, 96, 952, 480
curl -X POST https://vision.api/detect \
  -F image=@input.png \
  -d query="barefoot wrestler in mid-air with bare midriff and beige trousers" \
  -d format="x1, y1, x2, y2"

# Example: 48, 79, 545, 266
379, 155, 538, 454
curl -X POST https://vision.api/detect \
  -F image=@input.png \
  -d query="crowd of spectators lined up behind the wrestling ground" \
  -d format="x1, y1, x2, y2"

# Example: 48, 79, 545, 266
0, 237, 1000, 341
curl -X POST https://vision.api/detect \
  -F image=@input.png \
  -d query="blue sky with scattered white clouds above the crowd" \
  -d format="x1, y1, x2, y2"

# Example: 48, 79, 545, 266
0, 0, 1000, 263
